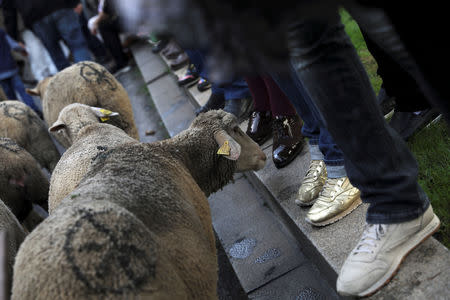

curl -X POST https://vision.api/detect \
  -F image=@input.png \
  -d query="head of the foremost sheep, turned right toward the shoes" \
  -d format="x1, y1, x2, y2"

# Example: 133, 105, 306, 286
191, 110, 266, 172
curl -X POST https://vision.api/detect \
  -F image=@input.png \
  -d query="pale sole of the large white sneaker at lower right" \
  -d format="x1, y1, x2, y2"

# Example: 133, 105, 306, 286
342, 214, 441, 297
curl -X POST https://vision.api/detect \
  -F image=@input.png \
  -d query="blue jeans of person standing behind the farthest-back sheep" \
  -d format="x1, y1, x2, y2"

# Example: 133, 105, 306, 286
33, 8, 92, 70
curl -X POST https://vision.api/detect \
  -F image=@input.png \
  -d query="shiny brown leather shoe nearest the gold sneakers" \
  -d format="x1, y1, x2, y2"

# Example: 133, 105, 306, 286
272, 115, 305, 169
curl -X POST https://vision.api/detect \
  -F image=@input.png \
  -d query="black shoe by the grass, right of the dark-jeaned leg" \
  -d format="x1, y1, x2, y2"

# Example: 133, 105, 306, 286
389, 108, 439, 141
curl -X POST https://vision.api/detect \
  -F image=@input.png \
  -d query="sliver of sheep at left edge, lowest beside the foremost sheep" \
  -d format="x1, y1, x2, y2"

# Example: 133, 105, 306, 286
0, 199, 26, 292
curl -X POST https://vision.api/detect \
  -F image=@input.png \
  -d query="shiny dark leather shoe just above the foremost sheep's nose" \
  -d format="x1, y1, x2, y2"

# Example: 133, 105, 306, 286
247, 111, 272, 145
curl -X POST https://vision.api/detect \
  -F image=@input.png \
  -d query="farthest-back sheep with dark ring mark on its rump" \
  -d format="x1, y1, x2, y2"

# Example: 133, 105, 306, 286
27, 61, 139, 148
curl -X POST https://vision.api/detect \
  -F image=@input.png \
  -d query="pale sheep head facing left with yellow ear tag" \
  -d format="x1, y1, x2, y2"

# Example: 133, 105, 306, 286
48, 103, 119, 145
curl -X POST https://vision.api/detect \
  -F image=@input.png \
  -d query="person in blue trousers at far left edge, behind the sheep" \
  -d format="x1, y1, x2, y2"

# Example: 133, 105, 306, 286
0, 28, 42, 118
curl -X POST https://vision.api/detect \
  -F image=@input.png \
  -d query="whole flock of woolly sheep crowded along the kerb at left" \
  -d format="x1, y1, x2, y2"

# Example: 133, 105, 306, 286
0, 62, 266, 299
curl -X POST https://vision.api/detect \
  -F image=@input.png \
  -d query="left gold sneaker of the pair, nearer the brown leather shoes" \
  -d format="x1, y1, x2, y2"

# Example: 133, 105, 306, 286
295, 160, 327, 206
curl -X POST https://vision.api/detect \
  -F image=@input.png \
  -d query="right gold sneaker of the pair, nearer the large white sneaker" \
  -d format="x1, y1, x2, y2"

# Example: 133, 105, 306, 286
306, 177, 361, 226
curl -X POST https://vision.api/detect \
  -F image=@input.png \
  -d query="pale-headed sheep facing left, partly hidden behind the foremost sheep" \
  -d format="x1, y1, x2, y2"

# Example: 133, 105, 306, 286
48, 103, 137, 213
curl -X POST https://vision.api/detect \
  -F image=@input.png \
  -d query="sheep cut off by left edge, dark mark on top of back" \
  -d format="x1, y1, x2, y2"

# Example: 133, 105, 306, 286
0, 101, 61, 172
